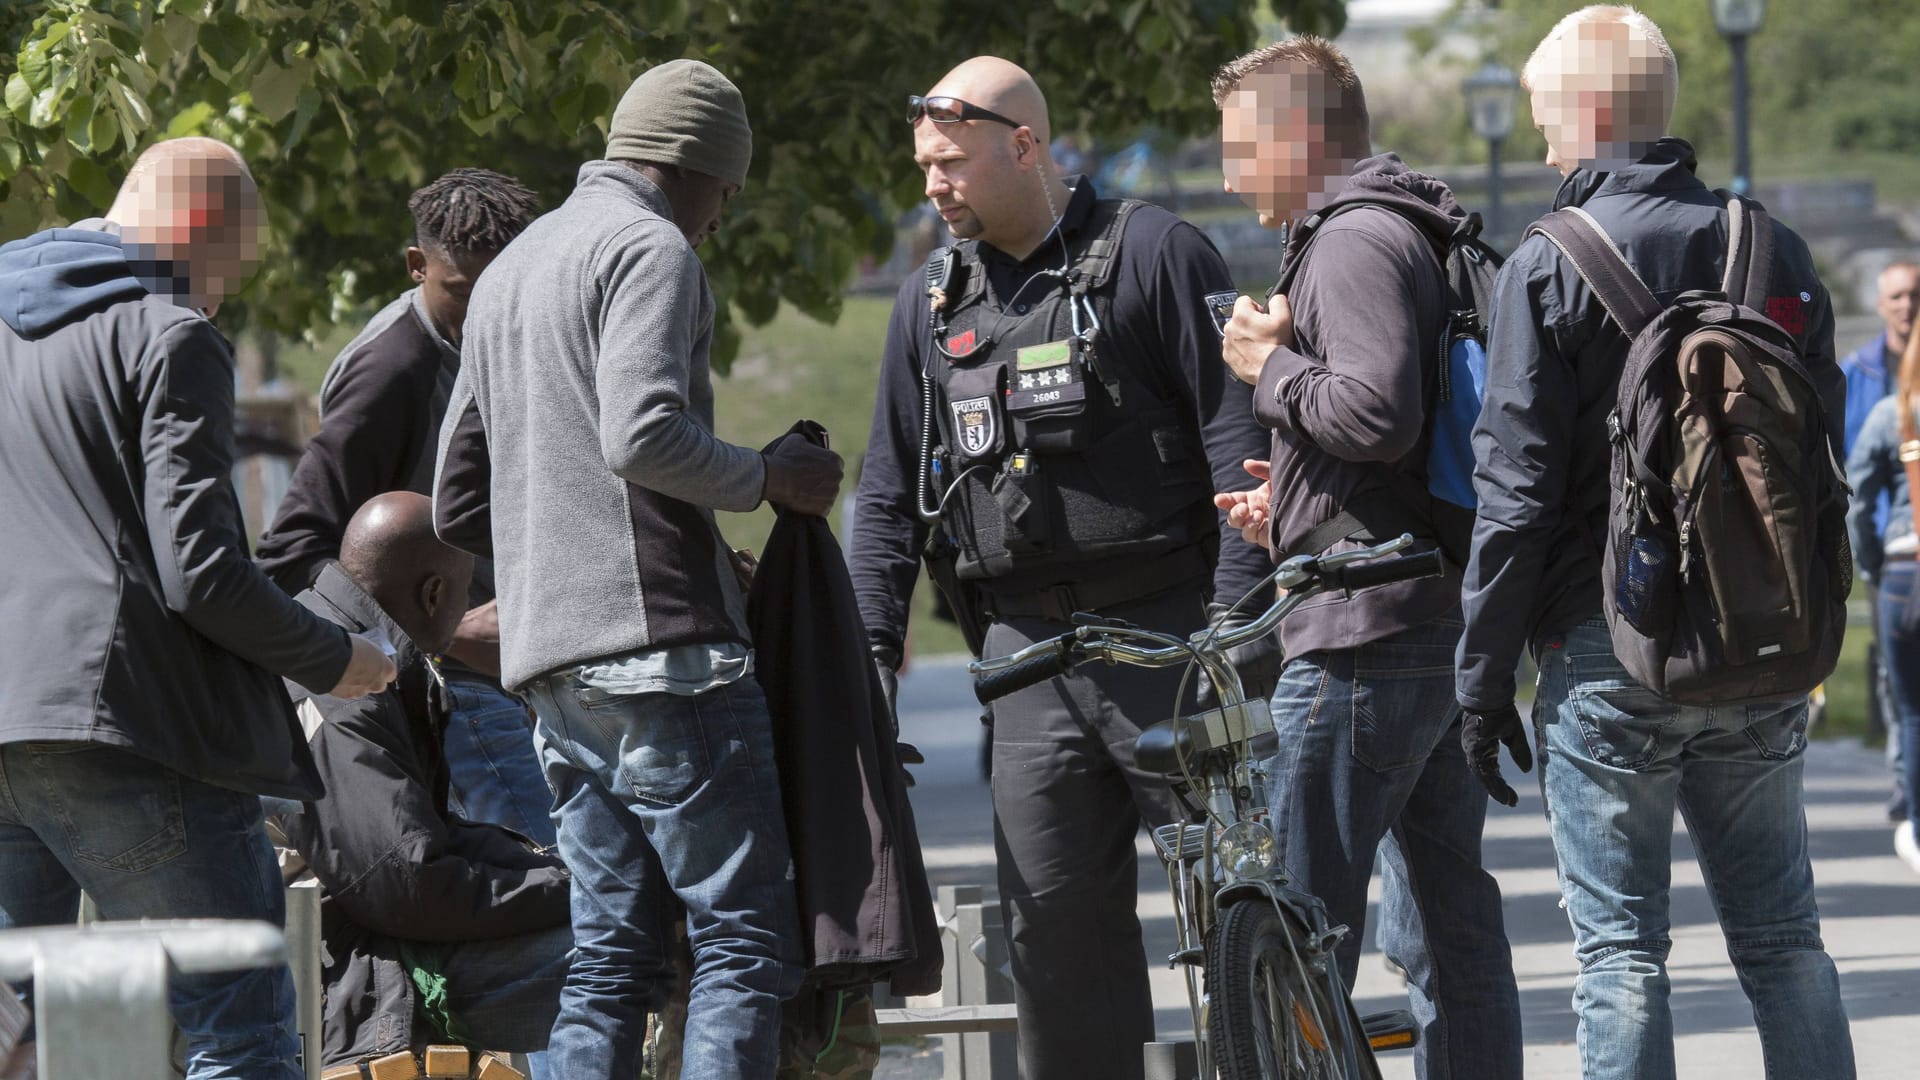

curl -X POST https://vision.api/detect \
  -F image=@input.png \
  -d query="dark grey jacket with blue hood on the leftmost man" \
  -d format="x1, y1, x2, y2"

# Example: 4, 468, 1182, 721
0, 221, 349, 798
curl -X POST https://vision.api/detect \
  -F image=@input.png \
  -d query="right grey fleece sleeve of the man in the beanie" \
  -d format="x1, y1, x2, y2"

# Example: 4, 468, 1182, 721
593, 223, 766, 511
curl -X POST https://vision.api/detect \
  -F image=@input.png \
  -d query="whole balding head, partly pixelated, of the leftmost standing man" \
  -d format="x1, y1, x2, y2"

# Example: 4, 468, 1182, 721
108, 136, 263, 313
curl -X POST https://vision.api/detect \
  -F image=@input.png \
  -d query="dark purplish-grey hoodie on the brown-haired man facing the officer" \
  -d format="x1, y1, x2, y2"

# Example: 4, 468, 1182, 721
1254, 154, 1467, 655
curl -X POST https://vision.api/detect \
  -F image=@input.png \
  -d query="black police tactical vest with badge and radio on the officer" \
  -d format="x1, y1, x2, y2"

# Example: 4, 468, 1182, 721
927, 200, 1217, 588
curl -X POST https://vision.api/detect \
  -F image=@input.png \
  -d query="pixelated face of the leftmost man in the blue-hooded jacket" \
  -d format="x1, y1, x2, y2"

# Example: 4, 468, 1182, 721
121, 161, 265, 315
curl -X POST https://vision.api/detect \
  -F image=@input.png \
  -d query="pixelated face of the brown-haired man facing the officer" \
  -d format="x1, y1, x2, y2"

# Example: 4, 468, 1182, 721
1219, 65, 1356, 229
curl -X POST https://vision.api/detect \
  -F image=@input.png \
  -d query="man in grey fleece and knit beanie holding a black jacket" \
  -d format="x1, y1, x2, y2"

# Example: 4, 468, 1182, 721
434, 60, 841, 1080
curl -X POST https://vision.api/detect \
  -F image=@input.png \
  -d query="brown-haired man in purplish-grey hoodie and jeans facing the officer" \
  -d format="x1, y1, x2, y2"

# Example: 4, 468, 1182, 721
1213, 37, 1521, 1080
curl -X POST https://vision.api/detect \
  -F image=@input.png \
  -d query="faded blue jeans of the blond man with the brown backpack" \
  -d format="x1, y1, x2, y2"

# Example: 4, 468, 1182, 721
1534, 619, 1853, 1080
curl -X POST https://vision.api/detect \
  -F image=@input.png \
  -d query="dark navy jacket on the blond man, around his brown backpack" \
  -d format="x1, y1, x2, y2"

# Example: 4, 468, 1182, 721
1457, 138, 1847, 711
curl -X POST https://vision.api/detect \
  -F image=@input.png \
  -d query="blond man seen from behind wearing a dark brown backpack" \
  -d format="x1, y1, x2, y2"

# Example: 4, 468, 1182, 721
1457, 8, 1855, 1080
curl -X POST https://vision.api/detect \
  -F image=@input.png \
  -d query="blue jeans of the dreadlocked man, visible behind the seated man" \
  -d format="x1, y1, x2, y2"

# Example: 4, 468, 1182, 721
444, 671, 553, 847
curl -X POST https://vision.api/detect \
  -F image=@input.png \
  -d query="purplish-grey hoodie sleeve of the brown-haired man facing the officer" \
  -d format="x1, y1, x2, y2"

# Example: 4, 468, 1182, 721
1254, 221, 1425, 461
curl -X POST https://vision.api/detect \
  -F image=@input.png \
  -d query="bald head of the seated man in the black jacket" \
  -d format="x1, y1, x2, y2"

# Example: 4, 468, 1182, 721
340, 492, 474, 653
